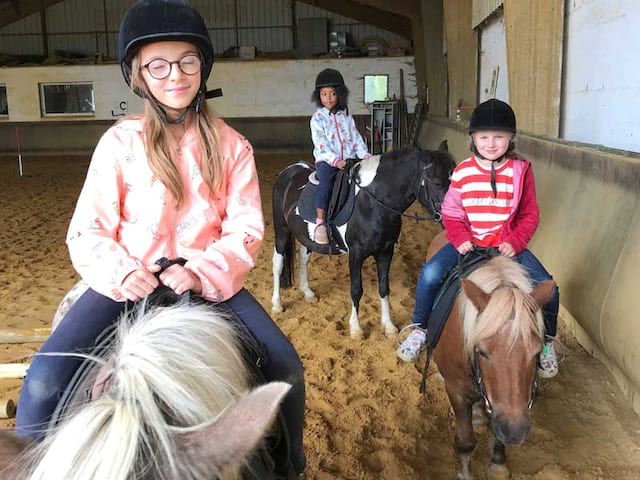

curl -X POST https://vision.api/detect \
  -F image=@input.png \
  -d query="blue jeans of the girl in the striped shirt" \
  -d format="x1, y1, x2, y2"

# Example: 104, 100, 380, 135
412, 248, 560, 337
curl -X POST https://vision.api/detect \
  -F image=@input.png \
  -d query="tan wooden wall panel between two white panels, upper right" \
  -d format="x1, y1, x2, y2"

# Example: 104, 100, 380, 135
504, 0, 564, 137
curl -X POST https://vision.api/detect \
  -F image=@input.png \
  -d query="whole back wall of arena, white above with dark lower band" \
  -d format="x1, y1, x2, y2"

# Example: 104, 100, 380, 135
0, 57, 417, 153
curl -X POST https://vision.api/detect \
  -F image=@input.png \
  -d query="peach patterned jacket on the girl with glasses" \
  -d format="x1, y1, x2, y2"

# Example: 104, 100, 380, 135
67, 118, 264, 301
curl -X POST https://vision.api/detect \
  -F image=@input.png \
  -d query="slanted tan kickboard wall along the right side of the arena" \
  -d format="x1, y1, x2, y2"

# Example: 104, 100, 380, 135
419, 114, 640, 414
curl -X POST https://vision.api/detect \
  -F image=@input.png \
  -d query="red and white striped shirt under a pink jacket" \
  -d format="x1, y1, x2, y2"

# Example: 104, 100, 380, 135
450, 156, 513, 247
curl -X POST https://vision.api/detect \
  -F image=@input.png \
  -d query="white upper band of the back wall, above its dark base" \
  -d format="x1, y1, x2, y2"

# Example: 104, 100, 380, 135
0, 57, 417, 122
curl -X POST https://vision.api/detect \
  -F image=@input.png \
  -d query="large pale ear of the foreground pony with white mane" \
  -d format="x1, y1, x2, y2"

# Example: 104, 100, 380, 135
175, 382, 291, 475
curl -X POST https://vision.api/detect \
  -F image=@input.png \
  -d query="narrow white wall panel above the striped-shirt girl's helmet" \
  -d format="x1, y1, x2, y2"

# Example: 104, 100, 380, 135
478, 15, 509, 102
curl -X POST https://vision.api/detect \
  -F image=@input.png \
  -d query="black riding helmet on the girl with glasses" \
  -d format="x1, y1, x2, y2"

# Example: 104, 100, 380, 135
118, 0, 217, 117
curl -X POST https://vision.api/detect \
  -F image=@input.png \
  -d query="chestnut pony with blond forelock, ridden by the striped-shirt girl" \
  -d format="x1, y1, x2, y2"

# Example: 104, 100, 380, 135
428, 233, 555, 480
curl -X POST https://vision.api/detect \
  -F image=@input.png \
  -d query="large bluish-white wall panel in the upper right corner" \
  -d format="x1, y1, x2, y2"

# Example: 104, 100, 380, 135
561, 0, 640, 152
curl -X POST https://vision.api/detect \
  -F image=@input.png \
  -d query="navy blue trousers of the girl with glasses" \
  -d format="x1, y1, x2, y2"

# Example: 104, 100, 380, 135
16, 289, 306, 473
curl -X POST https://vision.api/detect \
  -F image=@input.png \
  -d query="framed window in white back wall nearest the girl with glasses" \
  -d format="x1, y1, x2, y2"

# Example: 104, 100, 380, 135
40, 82, 96, 116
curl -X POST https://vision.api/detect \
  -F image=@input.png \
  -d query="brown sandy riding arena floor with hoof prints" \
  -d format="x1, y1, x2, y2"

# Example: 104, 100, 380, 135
0, 154, 640, 480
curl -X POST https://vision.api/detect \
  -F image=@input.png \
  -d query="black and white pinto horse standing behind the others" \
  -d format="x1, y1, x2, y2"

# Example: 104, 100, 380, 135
271, 141, 455, 339
